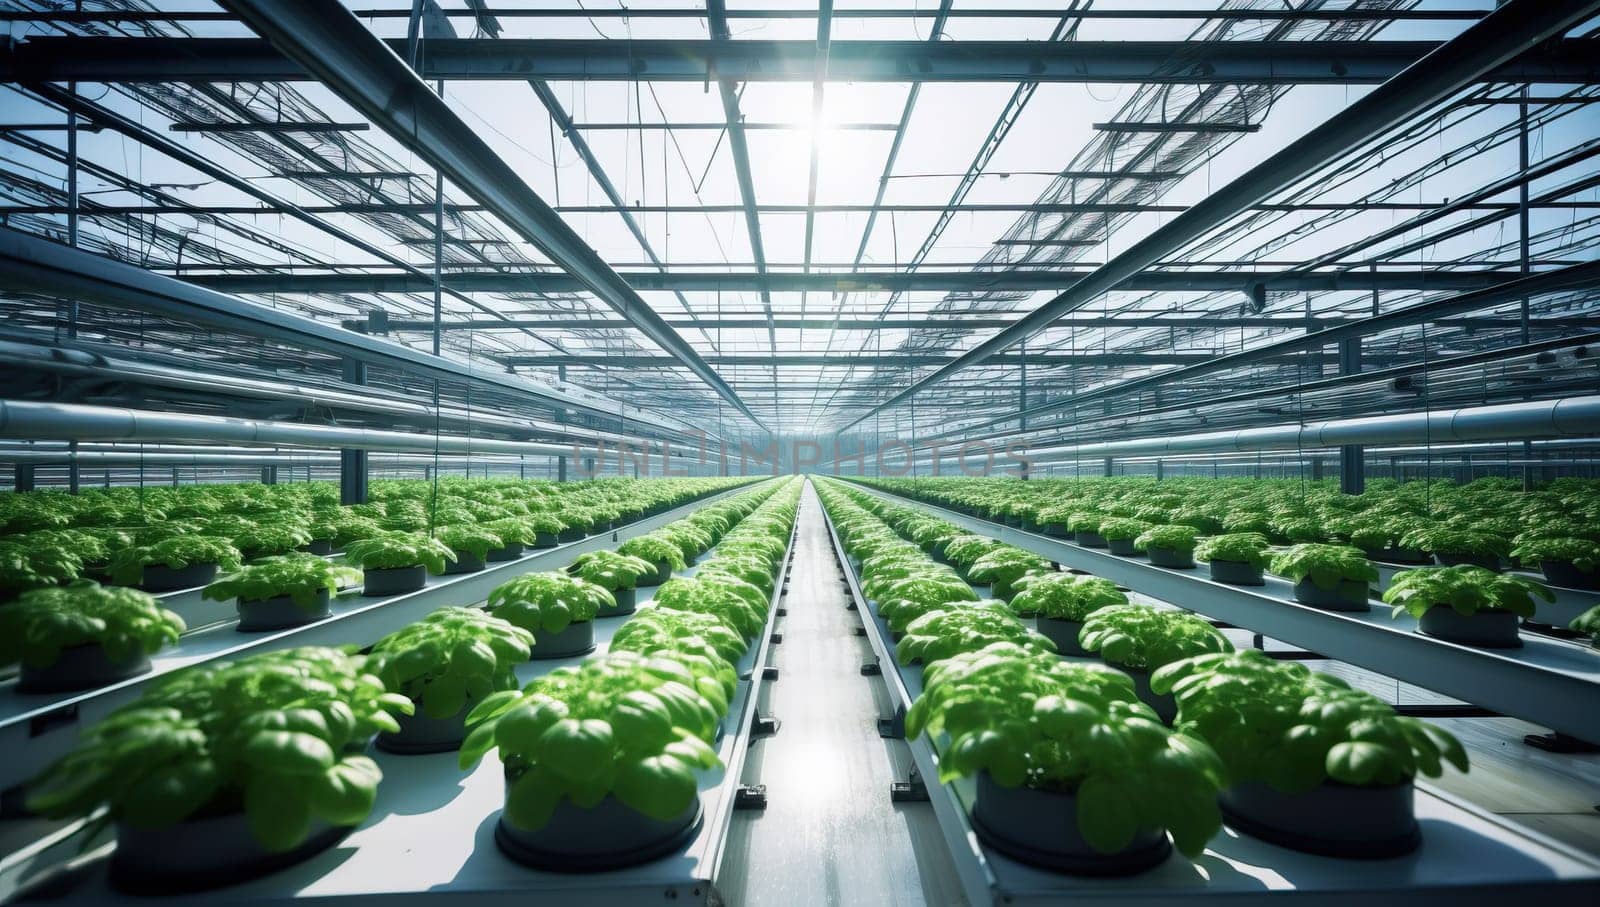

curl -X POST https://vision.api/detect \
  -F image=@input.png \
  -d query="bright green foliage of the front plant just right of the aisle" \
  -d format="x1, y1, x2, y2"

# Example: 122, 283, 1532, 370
906, 643, 1222, 856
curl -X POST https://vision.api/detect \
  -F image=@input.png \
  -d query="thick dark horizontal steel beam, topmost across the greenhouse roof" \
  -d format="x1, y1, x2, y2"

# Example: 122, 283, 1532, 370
0, 37, 1600, 85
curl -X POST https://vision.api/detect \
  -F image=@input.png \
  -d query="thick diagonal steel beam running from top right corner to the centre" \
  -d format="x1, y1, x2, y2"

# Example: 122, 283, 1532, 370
840, 0, 1600, 430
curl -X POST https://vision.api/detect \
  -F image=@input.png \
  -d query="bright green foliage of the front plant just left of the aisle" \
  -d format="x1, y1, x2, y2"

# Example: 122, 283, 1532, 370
461, 653, 728, 830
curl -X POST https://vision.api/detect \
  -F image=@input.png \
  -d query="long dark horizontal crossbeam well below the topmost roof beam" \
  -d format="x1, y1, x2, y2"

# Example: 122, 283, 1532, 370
184, 266, 1514, 294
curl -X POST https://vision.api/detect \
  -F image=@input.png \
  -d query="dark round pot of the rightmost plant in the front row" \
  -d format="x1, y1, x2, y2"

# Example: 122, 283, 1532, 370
1218, 781, 1422, 859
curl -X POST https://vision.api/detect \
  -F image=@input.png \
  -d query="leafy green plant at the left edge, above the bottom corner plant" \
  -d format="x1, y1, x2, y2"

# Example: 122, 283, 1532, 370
0, 579, 186, 669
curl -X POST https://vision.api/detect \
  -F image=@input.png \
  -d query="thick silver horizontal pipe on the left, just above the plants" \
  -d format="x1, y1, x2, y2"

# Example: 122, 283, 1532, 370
0, 400, 720, 461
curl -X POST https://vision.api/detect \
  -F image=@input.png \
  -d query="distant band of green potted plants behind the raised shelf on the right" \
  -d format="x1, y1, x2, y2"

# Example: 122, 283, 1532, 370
859, 477, 1600, 589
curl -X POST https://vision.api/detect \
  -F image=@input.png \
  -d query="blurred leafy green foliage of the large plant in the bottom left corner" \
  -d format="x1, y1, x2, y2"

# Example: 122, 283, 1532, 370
27, 648, 411, 851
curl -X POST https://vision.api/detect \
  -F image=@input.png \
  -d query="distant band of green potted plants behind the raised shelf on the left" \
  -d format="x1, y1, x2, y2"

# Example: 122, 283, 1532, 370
0, 478, 747, 601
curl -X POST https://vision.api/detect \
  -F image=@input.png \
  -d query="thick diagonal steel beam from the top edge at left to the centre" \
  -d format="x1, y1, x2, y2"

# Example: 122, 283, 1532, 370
224, 0, 765, 427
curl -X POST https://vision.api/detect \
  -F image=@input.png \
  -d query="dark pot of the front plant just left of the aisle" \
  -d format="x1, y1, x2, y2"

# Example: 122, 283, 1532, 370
494, 781, 701, 872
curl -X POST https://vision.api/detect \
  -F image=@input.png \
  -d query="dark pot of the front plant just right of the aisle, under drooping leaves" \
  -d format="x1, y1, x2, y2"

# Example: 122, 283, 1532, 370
971, 771, 1173, 875
